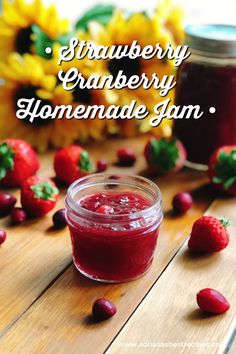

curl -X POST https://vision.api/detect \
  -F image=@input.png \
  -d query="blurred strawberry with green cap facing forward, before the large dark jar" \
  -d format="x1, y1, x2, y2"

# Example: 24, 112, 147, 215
144, 137, 187, 174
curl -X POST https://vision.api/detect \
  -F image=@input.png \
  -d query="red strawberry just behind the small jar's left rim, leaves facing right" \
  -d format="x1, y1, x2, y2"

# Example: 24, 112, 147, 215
54, 145, 92, 185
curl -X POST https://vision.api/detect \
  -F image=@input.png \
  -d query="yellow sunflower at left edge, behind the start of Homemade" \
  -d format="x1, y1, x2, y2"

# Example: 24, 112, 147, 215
0, 53, 78, 152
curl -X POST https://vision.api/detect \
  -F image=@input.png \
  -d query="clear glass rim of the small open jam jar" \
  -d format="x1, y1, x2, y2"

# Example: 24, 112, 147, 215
65, 173, 163, 223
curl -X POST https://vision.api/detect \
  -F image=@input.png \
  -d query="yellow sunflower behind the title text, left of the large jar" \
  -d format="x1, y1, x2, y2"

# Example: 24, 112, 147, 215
78, 10, 174, 136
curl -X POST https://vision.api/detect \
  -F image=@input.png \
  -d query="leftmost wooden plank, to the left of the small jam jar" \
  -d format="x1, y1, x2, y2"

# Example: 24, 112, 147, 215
0, 154, 72, 332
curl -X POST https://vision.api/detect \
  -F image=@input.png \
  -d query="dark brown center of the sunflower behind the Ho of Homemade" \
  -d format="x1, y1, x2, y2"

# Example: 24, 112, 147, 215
14, 85, 52, 126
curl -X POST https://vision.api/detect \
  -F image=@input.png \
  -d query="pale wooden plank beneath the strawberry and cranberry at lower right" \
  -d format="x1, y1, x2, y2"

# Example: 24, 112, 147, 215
107, 198, 236, 354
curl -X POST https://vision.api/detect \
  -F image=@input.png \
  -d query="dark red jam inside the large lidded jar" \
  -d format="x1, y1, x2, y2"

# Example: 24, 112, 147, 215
175, 62, 236, 164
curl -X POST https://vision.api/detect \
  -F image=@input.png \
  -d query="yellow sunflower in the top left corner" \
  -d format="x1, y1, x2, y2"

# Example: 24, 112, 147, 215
0, 0, 69, 59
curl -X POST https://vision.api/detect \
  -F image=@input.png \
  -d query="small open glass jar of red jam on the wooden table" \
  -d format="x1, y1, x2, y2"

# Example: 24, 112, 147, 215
66, 174, 163, 283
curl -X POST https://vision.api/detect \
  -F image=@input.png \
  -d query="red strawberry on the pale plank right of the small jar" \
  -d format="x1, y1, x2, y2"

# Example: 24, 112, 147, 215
188, 216, 229, 253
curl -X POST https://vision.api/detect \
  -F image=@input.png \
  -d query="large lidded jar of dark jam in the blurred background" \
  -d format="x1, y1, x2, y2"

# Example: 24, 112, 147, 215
174, 25, 236, 168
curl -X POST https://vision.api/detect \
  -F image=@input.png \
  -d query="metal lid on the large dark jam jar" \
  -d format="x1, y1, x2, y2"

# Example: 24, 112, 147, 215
185, 24, 236, 57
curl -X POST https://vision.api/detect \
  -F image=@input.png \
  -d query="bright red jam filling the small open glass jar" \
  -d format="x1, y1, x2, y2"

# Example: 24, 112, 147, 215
67, 176, 162, 282
